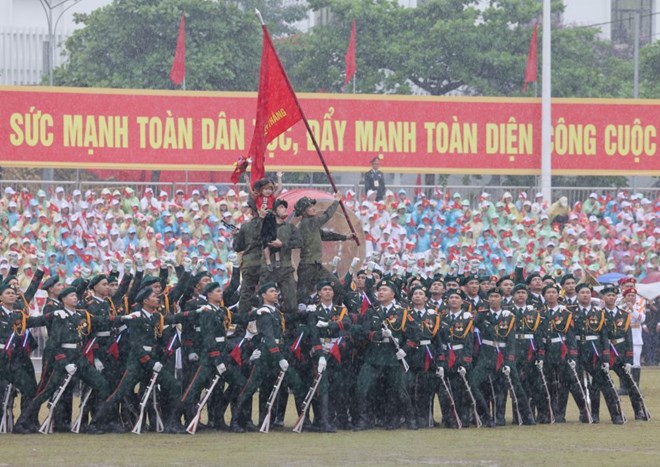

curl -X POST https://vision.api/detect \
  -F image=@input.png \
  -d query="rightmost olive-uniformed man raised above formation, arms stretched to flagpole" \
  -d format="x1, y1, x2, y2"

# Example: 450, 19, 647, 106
295, 193, 356, 304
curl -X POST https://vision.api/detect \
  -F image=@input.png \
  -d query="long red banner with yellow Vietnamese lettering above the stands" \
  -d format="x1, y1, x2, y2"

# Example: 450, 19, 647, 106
0, 87, 660, 176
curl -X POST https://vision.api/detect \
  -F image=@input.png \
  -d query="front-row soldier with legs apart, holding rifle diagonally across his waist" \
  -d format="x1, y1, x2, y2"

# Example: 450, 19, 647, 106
354, 280, 417, 430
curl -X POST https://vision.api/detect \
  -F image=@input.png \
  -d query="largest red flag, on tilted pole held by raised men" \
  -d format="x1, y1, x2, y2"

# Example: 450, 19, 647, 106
244, 26, 302, 184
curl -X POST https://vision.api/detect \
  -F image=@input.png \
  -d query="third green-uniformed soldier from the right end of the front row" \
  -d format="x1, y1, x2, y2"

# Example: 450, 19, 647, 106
540, 284, 587, 423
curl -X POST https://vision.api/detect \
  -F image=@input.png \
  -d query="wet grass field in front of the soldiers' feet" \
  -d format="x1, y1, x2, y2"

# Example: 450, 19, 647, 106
0, 368, 660, 466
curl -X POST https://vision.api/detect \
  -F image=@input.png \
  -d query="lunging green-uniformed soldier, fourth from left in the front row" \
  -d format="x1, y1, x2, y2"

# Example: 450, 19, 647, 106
165, 282, 245, 433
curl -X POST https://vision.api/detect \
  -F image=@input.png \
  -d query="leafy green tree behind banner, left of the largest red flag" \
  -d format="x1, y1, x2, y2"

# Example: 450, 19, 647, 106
55, 0, 304, 91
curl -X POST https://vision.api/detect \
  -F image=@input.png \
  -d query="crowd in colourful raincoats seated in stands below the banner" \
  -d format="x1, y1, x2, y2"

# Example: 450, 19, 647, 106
0, 185, 660, 288
